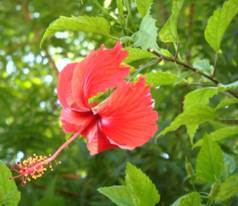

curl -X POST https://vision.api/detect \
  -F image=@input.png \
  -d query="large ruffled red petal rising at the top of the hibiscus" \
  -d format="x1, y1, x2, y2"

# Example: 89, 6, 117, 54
72, 43, 129, 111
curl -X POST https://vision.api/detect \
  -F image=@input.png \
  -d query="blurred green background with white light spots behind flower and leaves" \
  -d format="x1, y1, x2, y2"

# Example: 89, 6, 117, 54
0, 0, 238, 206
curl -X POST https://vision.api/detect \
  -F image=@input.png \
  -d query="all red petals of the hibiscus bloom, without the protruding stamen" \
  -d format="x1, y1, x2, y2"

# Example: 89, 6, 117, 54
58, 43, 158, 155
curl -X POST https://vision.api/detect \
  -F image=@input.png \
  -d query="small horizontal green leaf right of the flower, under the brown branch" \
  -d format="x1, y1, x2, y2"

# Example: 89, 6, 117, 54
146, 71, 178, 86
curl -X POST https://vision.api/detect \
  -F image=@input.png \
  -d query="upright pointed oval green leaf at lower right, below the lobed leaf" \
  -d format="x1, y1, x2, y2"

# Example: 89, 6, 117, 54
196, 136, 224, 183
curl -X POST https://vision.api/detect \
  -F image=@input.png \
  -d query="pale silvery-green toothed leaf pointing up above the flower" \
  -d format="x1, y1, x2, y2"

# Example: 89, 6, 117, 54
132, 12, 158, 50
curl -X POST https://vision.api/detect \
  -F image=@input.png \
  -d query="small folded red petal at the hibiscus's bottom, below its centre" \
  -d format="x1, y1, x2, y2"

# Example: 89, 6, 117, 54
82, 121, 117, 155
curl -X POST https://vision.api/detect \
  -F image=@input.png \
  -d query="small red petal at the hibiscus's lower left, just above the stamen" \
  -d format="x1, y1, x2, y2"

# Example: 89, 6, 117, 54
60, 108, 95, 133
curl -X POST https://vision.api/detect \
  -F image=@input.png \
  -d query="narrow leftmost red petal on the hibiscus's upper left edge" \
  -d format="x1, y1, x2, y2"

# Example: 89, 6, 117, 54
57, 63, 77, 107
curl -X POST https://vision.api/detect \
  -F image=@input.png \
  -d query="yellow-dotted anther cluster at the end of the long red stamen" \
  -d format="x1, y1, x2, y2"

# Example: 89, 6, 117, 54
13, 154, 53, 185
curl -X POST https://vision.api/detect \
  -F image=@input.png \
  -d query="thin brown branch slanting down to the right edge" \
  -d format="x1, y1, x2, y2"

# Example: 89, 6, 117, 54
153, 51, 238, 98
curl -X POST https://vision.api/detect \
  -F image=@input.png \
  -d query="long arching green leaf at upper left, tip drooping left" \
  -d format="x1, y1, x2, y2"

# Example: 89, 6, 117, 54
41, 16, 110, 46
